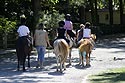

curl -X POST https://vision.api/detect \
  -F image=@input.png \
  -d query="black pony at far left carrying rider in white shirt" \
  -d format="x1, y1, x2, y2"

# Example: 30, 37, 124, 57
16, 37, 32, 71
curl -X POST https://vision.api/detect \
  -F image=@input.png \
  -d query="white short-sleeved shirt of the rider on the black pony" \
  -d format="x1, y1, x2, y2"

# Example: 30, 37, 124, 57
17, 25, 30, 37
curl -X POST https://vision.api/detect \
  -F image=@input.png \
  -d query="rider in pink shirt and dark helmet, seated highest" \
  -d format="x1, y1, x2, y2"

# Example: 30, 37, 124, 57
64, 14, 76, 40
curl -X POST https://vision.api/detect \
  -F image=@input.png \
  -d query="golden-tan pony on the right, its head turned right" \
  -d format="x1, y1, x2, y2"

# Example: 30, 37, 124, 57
78, 34, 96, 66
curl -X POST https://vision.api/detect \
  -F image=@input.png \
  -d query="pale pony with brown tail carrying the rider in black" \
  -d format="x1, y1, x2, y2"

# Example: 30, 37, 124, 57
53, 39, 69, 73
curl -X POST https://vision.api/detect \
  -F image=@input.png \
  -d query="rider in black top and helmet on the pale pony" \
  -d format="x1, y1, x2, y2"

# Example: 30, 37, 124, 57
56, 21, 69, 44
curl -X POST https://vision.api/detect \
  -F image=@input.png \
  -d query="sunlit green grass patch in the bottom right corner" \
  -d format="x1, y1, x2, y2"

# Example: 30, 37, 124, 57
88, 68, 125, 83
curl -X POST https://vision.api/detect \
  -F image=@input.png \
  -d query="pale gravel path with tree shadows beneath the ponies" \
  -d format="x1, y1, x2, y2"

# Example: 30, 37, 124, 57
0, 35, 125, 83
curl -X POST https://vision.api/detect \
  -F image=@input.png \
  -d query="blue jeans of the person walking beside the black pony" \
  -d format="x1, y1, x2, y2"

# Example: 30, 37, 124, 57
36, 46, 46, 62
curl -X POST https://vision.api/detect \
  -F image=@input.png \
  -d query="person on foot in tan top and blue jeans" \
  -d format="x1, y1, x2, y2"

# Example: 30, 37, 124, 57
34, 23, 51, 68
